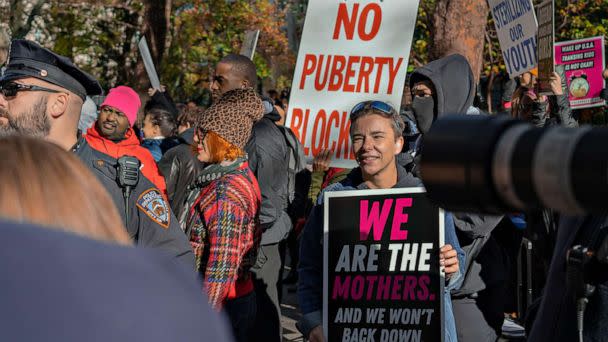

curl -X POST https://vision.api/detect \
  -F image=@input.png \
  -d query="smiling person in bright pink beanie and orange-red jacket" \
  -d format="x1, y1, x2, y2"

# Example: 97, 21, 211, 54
85, 86, 167, 196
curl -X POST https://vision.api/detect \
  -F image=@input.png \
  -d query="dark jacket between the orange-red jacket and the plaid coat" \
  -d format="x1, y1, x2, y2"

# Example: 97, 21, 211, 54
158, 128, 203, 217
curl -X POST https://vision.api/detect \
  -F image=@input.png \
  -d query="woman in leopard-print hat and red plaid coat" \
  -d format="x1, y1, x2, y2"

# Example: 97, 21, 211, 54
181, 89, 264, 341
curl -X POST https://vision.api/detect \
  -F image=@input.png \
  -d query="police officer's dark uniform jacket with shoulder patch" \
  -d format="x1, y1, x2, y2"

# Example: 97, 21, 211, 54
73, 137, 194, 269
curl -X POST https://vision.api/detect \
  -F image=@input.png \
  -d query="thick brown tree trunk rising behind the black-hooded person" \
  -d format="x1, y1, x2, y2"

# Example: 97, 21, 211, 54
430, 0, 489, 82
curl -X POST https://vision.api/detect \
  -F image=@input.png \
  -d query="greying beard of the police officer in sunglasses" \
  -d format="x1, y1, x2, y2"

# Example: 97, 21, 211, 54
0, 96, 51, 138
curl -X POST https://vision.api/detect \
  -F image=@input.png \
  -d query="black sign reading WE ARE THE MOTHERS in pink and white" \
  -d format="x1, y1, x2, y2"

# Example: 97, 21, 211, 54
323, 188, 444, 342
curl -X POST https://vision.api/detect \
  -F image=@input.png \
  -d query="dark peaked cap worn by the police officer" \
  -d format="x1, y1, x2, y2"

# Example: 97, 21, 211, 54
0, 39, 103, 100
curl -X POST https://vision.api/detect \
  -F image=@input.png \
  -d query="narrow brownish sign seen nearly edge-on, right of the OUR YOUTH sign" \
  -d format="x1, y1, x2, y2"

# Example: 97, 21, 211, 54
536, 0, 555, 94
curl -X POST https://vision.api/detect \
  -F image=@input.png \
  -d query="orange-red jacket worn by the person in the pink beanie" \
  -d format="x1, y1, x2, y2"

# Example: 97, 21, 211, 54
85, 123, 167, 197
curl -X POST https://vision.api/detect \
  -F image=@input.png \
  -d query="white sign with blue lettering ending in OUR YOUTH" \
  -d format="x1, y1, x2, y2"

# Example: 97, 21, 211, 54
488, 0, 538, 78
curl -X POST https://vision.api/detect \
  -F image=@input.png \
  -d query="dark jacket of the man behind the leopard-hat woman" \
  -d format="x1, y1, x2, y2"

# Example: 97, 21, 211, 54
245, 99, 292, 245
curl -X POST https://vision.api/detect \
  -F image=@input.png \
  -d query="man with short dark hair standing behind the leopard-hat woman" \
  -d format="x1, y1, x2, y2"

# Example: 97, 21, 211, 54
211, 54, 292, 342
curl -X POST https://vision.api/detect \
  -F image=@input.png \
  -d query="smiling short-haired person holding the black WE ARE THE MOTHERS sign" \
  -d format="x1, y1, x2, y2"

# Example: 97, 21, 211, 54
298, 101, 464, 342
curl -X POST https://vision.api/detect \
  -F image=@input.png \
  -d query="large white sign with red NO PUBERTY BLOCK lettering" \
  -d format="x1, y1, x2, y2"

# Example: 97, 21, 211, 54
286, 0, 418, 167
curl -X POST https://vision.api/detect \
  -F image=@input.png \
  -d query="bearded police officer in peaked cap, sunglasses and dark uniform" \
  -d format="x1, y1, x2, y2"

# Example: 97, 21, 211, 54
0, 40, 194, 267
